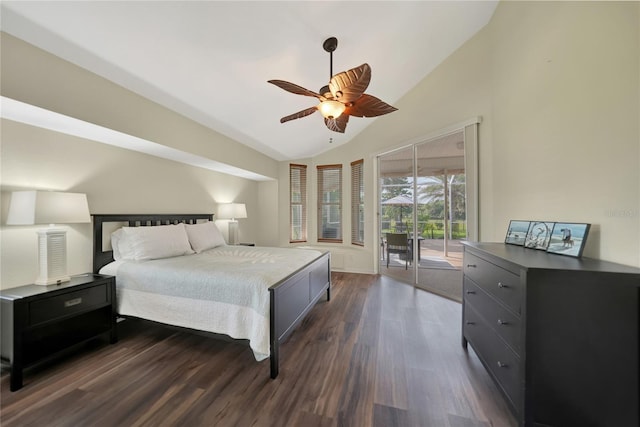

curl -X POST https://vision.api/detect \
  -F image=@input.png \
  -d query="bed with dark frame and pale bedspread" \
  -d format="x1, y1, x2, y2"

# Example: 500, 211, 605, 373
93, 214, 331, 378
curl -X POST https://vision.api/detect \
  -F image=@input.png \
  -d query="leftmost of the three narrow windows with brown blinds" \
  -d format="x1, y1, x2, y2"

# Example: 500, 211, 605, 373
289, 164, 307, 243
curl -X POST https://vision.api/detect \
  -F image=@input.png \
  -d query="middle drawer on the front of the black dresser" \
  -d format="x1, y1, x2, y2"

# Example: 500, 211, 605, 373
464, 277, 522, 354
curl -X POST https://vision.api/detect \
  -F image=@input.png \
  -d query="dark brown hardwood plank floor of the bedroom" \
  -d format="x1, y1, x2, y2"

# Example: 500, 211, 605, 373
0, 273, 516, 427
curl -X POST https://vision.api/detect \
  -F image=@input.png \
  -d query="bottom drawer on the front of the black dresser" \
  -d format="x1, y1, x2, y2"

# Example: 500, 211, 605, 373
463, 303, 522, 412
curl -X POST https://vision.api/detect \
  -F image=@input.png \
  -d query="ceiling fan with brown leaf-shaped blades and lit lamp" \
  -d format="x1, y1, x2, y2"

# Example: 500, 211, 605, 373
268, 37, 397, 133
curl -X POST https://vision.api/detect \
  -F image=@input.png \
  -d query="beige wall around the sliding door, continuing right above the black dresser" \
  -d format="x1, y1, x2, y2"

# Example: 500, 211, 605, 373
302, 2, 640, 271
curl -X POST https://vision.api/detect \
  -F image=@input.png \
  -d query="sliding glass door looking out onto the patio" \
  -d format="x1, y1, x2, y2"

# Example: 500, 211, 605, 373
378, 123, 477, 301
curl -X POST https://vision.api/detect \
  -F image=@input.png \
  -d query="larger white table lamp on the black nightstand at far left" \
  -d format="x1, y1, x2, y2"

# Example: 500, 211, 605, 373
7, 191, 91, 285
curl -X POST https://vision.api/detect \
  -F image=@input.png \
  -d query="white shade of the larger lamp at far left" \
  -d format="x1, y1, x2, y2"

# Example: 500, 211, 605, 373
7, 191, 91, 225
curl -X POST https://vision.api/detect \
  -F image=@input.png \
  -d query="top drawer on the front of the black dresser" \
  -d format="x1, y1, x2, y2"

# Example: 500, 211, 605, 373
464, 252, 522, 315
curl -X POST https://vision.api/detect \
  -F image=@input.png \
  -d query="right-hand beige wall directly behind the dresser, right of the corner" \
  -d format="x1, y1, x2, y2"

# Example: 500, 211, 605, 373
491, 2, 640, 265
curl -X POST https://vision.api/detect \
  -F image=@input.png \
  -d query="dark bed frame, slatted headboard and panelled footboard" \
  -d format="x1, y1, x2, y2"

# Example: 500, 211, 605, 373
92, 214, 331, 378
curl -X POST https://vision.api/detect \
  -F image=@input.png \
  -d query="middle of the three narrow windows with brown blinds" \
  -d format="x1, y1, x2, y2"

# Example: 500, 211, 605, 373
318, 165, 342, 242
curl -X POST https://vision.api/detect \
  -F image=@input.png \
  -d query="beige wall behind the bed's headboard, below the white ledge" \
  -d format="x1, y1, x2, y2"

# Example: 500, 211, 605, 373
0, 120, 262, 288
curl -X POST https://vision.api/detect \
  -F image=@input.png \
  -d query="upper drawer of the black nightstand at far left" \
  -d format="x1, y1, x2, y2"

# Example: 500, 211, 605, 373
29, 283, 109, 326
